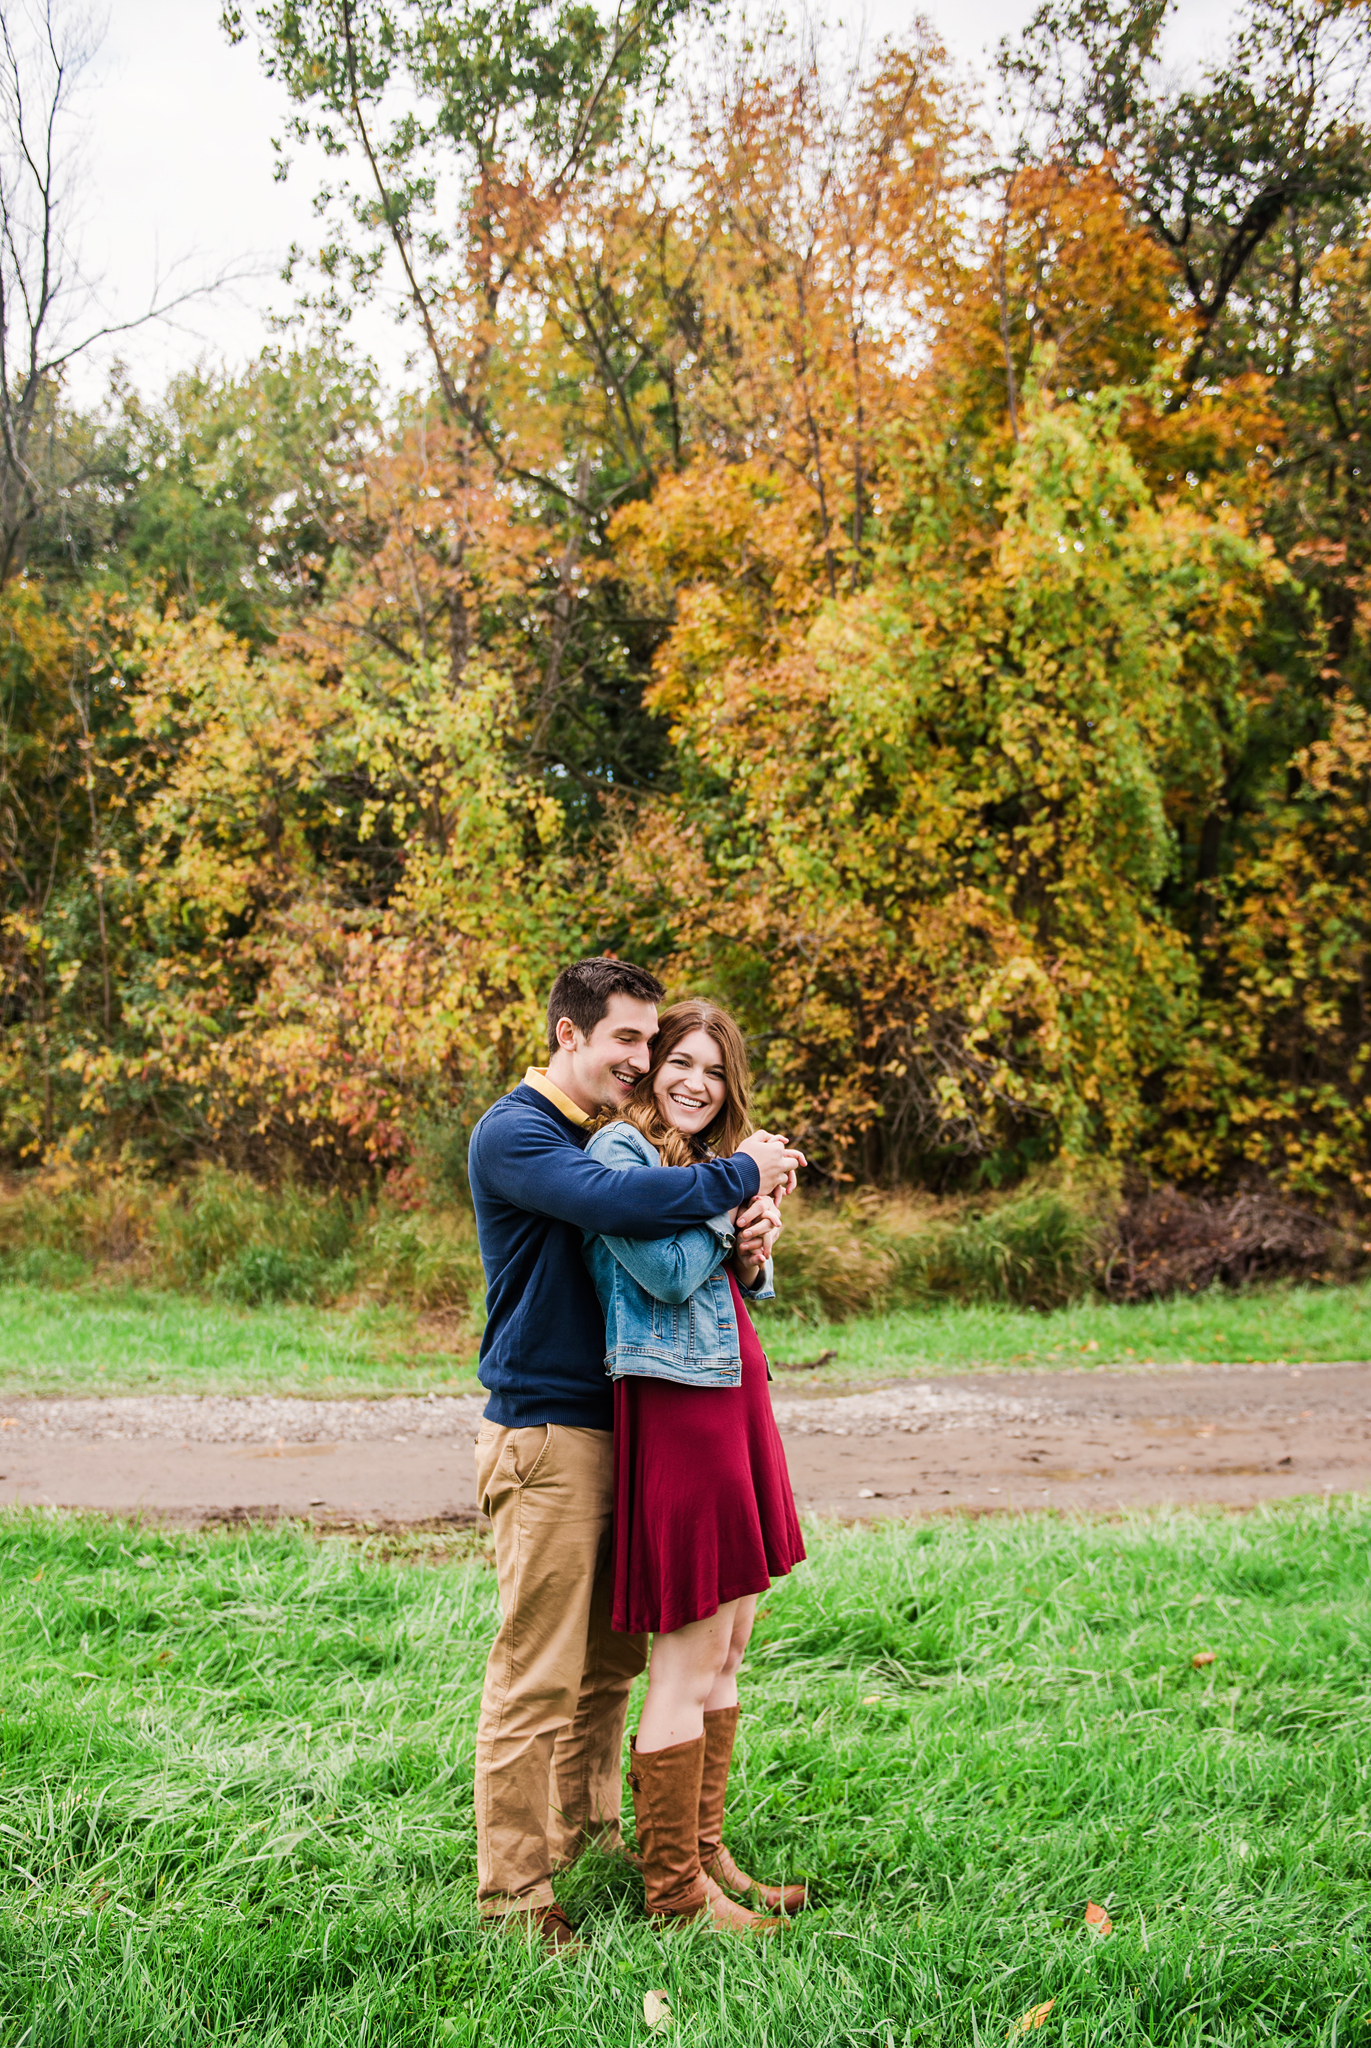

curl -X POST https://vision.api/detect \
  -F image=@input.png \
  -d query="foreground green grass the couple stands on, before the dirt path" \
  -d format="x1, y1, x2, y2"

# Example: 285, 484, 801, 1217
0, 1503, 1371, 2048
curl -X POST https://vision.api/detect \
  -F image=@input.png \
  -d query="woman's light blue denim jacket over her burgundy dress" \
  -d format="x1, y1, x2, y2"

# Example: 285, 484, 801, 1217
582, 1122, 775, 1386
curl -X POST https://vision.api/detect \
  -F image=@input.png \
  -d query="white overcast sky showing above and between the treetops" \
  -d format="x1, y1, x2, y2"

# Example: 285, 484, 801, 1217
64, 0, 1236, 397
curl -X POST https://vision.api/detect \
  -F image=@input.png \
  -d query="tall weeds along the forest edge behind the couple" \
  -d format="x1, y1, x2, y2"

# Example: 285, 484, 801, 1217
0, 1167, 1119, 1321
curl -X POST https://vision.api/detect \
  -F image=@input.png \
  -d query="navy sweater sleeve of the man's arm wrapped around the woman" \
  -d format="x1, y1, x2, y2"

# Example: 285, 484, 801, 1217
471, 1110, 760, 1237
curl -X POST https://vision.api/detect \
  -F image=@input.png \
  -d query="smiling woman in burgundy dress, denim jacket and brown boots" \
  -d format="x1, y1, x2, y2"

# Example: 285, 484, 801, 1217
586, 1001, 805, 1933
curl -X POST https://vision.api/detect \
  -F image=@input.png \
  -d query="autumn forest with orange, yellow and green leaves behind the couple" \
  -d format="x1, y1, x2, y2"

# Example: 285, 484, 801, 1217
0, 0, 1371, 1310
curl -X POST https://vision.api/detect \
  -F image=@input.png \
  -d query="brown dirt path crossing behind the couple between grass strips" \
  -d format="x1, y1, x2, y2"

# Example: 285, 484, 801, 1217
0, 1364, 1371, 1526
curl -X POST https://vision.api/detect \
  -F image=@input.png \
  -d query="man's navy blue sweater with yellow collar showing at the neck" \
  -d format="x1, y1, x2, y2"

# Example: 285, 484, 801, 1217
467, 1083, 760, 1430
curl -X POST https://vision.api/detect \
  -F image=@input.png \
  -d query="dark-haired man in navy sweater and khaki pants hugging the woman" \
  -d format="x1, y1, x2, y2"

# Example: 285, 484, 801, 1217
469, 958, 803, 1952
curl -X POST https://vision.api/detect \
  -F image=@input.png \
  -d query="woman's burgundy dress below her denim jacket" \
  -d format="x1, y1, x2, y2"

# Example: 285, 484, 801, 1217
613, 1274, 805, 1636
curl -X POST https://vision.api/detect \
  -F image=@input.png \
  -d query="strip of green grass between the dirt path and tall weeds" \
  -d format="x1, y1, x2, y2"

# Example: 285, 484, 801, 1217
0, 1282, 1371, 1395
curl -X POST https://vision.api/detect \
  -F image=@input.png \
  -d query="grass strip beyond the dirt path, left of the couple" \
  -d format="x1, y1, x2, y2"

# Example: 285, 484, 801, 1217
0, 1286, 477, 1395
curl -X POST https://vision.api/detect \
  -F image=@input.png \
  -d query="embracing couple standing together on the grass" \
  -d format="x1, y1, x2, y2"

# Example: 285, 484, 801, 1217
469, 958, 805, 1952
